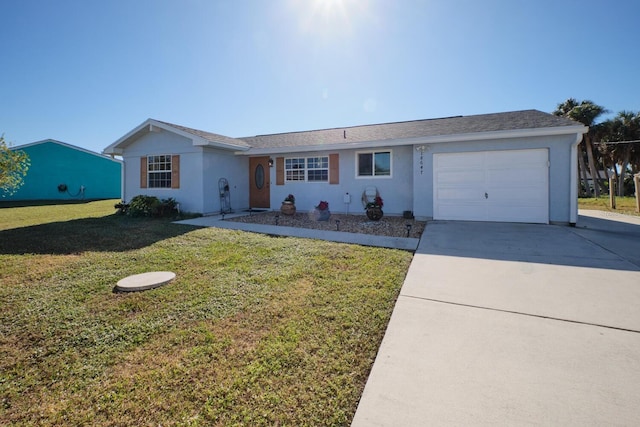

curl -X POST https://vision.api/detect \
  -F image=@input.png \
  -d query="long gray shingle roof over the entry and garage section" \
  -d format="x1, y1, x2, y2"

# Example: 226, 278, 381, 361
238, 110, 581, 148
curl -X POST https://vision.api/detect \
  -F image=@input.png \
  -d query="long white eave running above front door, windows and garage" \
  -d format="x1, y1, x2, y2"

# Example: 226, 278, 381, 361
236, 125, 589, 156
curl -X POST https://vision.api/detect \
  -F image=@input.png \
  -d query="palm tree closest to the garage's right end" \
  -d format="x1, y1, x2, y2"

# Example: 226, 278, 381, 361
553, 98, 607, 197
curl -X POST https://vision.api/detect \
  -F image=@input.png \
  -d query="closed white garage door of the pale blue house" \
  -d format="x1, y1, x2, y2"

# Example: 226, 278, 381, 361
433, 149, 549, 224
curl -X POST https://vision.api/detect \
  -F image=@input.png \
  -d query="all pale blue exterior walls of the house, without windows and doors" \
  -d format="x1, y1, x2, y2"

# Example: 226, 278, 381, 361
115, 123, 575, 223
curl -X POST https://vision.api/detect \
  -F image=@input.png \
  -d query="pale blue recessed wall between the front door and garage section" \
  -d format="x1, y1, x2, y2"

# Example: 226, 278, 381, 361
266, 146, 413, 215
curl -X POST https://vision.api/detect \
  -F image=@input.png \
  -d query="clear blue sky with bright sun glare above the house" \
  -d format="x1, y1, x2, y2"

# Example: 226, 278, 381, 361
0, 0, 640, 152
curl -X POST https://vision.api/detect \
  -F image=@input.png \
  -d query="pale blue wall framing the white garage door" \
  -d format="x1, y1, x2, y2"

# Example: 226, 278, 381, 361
412, 135, 575, 223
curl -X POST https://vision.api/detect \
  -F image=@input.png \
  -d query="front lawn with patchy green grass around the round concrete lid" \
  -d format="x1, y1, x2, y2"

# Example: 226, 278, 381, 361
0, 201, 412, 426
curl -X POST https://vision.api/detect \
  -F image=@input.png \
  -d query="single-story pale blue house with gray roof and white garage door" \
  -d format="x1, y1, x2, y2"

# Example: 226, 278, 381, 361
104, 110, 588, 224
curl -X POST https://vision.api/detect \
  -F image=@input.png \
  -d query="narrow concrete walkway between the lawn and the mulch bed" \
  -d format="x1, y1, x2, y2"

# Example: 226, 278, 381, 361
177, 213, 419, 251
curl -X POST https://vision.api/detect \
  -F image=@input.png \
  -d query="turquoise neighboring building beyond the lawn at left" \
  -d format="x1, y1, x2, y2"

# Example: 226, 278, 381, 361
6, 139, 122, 201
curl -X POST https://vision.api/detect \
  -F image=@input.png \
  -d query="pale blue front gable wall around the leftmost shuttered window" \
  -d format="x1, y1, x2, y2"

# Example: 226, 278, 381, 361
123, 130, 204, 213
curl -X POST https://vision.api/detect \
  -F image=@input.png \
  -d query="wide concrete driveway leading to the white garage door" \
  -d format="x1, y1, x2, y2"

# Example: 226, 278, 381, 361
353, 211, 640, 426
